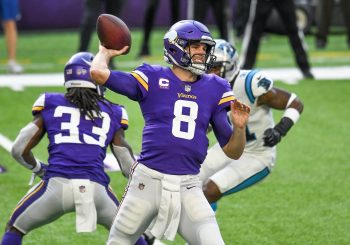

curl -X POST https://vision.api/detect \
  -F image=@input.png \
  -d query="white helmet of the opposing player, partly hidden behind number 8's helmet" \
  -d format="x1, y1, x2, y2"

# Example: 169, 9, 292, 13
214, 39, 239, 82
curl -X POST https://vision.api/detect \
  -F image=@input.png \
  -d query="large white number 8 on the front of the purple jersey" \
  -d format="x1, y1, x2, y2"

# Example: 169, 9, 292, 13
171, 100, 198, 140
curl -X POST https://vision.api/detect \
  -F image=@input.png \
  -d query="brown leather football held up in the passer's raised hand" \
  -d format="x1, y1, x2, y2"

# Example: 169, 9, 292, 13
96, 14, 131, 54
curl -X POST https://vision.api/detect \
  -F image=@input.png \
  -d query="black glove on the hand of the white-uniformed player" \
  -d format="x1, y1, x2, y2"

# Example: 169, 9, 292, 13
264, 117, 294, 147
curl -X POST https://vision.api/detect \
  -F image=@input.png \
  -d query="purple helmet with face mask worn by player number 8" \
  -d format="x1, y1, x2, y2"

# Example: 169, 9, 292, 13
164, 20, 215, 75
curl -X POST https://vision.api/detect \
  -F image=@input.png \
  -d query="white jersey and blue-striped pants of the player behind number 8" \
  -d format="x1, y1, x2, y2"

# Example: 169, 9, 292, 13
199, 70, 276, 193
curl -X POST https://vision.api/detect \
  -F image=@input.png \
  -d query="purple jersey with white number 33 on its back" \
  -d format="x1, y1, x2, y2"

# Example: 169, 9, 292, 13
32, 93, 128, 185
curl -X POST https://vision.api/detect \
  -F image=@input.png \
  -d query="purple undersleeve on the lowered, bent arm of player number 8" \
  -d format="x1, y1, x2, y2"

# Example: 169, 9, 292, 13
211, 108, 233, 147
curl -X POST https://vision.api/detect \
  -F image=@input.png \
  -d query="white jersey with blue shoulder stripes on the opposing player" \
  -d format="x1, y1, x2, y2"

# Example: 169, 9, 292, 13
233, 70, 275, 154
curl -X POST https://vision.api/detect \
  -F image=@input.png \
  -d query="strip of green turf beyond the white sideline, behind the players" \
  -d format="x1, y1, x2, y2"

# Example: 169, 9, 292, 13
0, 28, 350, 74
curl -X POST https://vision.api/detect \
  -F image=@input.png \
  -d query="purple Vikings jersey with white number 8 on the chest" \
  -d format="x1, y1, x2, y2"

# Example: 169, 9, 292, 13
119, 64, 235, 175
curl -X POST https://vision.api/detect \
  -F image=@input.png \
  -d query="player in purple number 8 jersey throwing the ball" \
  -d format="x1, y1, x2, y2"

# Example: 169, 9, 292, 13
91, 20, 249, 245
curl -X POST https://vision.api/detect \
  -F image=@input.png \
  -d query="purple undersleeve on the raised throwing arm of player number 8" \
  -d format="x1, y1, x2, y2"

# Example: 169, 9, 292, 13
105, 71, 142, 101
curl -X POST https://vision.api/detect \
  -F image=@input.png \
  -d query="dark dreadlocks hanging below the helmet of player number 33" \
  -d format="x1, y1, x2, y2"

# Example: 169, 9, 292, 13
65, 88, 105, 121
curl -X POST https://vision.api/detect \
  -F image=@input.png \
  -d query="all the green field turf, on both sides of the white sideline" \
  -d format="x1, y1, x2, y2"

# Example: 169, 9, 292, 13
0, 27, 350, 245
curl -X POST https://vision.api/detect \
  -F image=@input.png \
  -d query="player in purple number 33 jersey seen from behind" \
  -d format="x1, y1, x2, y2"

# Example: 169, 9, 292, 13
1, 52, 146, 245
